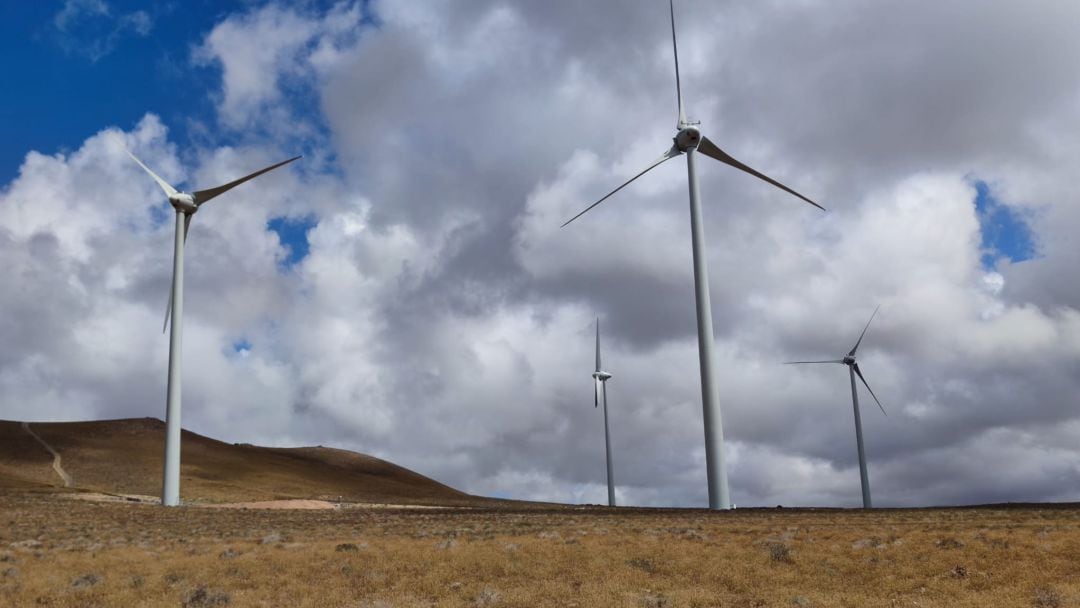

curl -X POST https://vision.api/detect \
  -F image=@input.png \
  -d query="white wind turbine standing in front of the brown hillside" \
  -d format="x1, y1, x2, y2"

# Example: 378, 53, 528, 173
127, 151, 300, 506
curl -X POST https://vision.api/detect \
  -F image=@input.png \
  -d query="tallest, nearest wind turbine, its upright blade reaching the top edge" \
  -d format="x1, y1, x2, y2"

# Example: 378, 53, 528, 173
563, 0, 824, 509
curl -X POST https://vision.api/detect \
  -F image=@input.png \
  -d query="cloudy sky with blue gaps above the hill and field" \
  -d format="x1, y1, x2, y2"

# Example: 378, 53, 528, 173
0, 0, 1080, 506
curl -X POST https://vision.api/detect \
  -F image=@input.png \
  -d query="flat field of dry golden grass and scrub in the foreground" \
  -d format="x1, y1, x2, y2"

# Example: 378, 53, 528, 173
0, 487, 1080, 608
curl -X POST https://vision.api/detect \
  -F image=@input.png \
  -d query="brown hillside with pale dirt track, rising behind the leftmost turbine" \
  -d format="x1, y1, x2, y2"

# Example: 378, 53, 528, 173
0, 418, 499, 505
